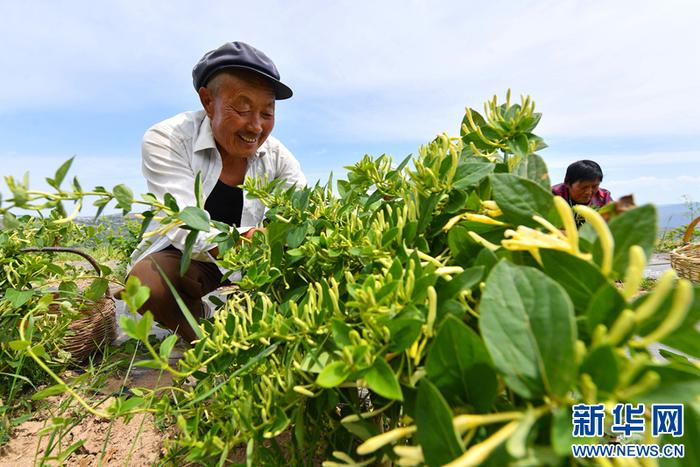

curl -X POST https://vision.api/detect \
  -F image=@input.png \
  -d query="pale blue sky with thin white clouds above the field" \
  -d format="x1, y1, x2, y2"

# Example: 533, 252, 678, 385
0, 0, 700, 214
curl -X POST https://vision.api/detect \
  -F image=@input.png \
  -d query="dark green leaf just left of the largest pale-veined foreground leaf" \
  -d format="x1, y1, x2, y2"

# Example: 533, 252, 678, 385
425, 315, 498, 413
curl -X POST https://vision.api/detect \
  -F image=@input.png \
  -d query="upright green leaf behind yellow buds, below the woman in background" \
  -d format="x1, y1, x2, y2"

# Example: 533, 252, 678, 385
593, 204, 656, 279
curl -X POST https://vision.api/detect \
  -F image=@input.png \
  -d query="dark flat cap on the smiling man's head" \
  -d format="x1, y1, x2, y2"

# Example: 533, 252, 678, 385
192, 42, 292, 99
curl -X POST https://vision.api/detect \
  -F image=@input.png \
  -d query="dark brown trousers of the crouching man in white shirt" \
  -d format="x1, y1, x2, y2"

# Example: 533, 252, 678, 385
129, 246, 222, 342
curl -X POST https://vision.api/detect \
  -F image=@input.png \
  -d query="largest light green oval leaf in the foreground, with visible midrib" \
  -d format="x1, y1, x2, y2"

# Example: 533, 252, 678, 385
479, 260, 577, 399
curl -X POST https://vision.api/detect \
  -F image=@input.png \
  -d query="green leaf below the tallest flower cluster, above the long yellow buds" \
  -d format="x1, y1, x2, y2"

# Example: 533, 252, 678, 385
490, 174, 554, 227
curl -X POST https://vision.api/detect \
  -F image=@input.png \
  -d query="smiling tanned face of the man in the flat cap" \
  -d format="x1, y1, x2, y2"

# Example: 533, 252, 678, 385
200, 74, 275, 158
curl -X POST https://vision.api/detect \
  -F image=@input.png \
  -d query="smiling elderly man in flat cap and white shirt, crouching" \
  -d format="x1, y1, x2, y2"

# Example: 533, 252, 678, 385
129, 42, 306, 341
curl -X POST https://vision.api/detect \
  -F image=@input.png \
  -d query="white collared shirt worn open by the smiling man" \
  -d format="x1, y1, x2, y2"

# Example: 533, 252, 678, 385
131, 110, 306, 266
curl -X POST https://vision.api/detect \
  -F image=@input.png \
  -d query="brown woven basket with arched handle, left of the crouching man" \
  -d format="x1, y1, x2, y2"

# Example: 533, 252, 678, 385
22, 247, 117, 361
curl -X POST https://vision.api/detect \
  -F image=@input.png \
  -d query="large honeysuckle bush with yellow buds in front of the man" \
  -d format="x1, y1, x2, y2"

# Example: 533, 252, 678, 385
2, 94, 700, 466
